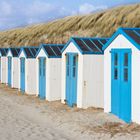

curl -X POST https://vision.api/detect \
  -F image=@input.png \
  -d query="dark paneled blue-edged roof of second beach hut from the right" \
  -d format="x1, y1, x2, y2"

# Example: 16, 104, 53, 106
62, 37, 109, 54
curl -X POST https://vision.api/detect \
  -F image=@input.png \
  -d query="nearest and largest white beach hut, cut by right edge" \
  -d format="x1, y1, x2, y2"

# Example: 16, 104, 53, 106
103, 28, 140, 123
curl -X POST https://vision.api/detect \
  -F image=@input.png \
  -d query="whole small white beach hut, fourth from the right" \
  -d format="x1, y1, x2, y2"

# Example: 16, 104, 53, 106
19, 47, 39, 95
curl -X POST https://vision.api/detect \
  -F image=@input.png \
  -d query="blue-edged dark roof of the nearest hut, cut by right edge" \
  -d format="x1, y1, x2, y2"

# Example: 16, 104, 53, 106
103, 28, 140, 50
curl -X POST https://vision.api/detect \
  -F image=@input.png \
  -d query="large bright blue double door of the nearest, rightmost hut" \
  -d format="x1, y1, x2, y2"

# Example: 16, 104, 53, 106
111, 49, 131, 122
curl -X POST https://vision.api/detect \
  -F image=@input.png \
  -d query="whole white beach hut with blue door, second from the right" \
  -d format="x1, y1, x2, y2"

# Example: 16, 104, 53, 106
61, 37, 108, 108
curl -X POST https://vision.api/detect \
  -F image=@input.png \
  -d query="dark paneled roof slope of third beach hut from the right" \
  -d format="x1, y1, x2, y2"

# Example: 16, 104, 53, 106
42, 44, 65, 58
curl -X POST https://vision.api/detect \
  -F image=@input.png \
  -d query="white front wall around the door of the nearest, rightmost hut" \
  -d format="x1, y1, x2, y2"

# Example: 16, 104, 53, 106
104, 34, 140, 123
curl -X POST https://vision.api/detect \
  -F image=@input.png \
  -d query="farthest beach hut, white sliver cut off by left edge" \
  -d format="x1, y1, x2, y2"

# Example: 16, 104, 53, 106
0, 48, 8, 84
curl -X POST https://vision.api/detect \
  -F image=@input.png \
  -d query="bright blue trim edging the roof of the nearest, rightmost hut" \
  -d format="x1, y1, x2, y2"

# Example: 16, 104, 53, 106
103, 28, 140, 50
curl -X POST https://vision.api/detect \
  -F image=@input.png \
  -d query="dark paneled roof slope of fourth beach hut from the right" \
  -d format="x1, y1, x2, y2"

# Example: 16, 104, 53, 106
22, 47, 39, 58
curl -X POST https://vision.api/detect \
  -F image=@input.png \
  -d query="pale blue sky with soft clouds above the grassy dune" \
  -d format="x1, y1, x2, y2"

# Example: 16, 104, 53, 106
0, 0, 140, 30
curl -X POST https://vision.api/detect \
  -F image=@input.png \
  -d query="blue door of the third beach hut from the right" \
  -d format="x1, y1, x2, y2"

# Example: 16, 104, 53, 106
39, 57, 46, 99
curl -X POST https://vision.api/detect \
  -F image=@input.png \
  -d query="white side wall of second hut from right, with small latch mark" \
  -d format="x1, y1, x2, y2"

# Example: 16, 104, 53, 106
82, 55, 104, 108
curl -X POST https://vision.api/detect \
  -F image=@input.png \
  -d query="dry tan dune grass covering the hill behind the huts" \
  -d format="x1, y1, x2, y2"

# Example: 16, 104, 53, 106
0, 4, 140, 47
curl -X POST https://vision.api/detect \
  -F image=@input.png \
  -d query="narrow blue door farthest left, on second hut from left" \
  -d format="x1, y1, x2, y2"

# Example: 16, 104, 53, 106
8, 57, 12, 86
